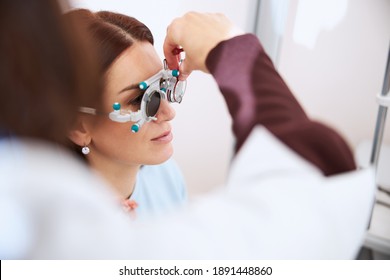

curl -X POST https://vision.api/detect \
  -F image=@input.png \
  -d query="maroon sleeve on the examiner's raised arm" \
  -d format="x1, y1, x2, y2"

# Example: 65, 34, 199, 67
206, 34, 356, 175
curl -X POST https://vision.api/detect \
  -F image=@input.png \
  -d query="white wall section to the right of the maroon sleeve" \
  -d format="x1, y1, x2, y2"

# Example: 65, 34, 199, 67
278, 0, 390, 153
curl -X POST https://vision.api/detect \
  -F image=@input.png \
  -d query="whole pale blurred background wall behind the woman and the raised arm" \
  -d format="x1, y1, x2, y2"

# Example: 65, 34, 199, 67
71, 0, 390, 195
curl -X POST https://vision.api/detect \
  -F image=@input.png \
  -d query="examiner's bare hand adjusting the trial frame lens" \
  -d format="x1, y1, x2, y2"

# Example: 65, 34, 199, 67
164, 12, 243, 80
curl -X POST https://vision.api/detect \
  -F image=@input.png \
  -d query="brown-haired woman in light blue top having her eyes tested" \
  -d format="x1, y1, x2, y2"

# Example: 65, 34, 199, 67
67, 9, 186, 218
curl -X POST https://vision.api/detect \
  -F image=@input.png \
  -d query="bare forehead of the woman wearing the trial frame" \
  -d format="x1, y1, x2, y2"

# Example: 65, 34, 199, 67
105, 42, 162, 92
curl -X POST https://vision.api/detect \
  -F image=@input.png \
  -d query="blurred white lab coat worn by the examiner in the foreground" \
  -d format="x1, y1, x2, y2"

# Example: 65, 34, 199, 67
0, 126, 375, 259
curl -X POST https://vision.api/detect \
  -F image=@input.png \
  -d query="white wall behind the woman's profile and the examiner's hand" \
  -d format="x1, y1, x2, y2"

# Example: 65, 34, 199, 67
72, 0, 257, 194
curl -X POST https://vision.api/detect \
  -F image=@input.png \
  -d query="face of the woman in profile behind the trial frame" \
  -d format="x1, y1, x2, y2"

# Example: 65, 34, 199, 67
88, 42, 175, 165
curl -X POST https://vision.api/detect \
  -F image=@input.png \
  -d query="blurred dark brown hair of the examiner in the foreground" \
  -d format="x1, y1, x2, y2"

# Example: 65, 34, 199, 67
0, 0, 101, 143
